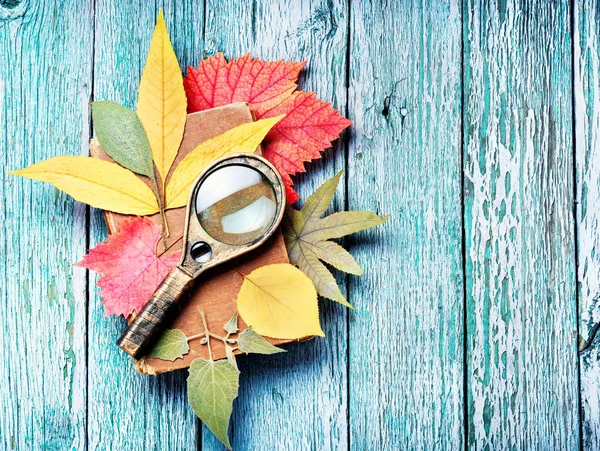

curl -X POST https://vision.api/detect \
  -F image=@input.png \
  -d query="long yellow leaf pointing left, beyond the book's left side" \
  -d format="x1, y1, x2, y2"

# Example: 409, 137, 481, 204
10, 157, 158, 216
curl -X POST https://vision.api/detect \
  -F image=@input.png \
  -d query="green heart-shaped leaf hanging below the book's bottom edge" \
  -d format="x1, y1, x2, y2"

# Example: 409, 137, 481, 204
187, 359, 239, 449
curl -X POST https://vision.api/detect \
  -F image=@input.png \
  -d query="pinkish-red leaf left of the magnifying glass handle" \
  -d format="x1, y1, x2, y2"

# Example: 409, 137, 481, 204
75, 217, 181, 316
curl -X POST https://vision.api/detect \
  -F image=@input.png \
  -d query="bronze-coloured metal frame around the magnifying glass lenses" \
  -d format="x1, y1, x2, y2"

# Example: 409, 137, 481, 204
179, 153, 286, 276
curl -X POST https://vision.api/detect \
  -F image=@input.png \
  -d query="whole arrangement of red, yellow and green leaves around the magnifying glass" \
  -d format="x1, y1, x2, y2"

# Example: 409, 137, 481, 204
14, 12, 385, 446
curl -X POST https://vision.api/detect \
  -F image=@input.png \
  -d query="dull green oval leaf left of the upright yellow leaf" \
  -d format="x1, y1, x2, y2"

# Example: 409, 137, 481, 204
92, 101, 155, 180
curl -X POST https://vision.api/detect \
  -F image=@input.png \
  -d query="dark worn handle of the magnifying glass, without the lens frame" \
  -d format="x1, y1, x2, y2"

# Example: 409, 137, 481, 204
117, 267, 194, 358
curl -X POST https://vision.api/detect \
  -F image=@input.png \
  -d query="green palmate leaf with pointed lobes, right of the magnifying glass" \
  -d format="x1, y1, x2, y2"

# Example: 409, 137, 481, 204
283, 171, 387, 307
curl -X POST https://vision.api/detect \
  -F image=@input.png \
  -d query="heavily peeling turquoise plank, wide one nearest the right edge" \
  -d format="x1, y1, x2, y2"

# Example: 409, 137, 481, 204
464, 0, 579, 450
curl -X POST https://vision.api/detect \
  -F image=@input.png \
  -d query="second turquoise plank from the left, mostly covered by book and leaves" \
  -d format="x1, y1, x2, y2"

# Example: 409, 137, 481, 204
88, 0, 203, 449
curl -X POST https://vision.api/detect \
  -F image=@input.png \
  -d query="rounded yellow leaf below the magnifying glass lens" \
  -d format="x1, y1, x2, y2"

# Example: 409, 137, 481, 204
237, 263, 325, 340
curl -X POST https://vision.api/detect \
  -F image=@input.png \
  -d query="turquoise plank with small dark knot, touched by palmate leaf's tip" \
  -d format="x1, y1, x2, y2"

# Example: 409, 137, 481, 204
348, 0, 463, 449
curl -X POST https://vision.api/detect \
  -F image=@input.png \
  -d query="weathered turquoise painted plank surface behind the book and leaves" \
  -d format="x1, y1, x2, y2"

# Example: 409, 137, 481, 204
0, 0, 600, 451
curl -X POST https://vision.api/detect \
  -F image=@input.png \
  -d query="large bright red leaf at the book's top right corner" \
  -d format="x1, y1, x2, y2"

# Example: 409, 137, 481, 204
183, 53, 352, 203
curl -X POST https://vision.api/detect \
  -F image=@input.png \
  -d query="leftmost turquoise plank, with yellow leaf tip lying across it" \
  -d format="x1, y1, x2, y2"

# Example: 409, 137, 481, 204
0, 0, 93, 449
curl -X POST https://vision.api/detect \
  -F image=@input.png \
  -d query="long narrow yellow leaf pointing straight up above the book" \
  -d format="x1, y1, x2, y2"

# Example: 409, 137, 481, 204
137, 9, 187, 186
